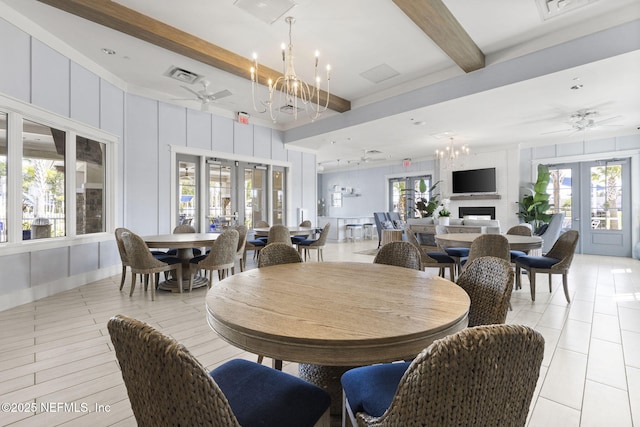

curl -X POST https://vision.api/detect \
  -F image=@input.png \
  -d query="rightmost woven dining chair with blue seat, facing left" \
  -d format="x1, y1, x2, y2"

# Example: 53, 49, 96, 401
515, 230, 580, 303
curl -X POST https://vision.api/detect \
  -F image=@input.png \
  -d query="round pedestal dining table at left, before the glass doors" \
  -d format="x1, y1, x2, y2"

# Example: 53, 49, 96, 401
142, 233, 220, 292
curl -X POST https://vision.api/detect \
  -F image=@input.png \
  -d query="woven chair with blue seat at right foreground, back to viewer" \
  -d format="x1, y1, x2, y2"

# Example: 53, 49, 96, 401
341, 325, 544, 426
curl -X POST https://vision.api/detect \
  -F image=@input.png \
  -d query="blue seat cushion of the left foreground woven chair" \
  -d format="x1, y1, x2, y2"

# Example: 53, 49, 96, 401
210, 359, 331, 427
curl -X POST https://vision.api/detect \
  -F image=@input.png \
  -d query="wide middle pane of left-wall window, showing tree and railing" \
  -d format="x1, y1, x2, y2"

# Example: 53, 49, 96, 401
22, 120, 66, 239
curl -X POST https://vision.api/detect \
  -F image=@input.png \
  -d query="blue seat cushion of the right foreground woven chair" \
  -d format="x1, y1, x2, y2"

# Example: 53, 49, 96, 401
340, 362, 410, 417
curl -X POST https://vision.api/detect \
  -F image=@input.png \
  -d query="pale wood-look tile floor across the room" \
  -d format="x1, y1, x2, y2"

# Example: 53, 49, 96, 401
0, 240, 640, 427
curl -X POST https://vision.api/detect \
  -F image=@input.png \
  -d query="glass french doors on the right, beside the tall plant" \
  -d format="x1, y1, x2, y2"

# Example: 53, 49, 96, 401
548, 159, 632, 256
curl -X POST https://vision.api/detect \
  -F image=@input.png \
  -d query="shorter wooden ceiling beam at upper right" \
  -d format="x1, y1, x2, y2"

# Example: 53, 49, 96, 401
393, 0, 484, 73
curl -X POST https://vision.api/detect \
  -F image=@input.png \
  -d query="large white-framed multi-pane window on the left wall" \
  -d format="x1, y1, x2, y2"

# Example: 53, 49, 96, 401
0, 100, 116, 246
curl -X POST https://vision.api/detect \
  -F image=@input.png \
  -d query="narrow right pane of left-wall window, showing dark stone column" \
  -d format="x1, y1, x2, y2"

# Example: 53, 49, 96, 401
76, 136, 106, 235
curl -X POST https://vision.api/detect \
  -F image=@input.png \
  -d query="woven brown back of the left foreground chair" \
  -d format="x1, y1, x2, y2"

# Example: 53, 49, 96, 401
107, 315, 240, 427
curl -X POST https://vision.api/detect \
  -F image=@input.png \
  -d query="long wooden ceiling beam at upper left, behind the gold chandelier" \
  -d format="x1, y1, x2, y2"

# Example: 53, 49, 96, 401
38, 0, 351, 113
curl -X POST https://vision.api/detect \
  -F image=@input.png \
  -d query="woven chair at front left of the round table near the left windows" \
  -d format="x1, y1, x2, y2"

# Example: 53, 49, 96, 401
121, 231, 182, 301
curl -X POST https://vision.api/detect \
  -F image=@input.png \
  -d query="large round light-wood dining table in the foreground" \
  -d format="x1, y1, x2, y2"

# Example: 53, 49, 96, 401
206, 262, 470, 415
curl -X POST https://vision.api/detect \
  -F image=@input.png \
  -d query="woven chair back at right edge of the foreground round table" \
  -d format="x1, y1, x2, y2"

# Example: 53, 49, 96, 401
457, 257, 514, 326
